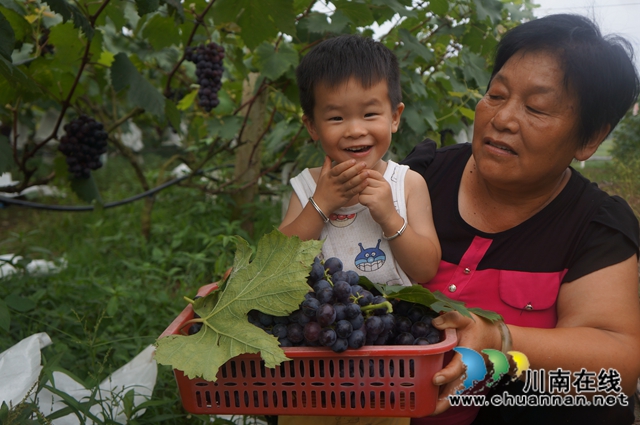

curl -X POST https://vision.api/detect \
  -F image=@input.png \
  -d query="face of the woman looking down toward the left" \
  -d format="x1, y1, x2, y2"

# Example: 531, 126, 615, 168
473, 52, 596, 191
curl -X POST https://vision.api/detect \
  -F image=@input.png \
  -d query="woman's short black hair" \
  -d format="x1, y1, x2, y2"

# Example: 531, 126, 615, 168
489, 14, 640, 146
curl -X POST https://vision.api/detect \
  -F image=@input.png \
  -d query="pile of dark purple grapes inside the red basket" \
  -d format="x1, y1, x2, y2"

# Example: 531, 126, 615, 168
242, 257, 440, 353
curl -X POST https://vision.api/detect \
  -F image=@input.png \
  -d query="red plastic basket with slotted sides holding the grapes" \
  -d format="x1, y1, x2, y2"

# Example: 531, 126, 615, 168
160, 284, 457, 418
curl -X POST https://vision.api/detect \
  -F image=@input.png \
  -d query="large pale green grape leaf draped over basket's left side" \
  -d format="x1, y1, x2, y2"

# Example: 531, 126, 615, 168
156, 230, 322, 382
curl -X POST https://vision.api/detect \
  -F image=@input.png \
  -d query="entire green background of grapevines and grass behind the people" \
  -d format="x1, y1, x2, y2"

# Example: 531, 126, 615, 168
0, 0, 637, 423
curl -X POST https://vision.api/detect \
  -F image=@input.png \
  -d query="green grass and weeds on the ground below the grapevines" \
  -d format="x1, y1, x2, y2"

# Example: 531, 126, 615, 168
0, 154, 280, 424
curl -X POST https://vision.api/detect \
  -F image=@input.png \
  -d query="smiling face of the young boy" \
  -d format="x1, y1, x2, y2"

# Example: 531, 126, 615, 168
303, 78, 404, 172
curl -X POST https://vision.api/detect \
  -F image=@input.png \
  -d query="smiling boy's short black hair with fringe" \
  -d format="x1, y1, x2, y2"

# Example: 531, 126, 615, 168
296, 35, 402, 120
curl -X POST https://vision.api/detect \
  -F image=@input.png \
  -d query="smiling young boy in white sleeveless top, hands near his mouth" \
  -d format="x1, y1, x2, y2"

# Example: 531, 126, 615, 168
279, 35, 440, 286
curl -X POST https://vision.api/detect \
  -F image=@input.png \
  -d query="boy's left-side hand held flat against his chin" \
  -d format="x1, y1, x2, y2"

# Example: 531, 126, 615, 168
313, 156, 371, 216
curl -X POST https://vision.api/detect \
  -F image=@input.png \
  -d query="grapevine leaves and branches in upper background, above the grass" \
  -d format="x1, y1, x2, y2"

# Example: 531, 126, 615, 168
0, 0, 532, 236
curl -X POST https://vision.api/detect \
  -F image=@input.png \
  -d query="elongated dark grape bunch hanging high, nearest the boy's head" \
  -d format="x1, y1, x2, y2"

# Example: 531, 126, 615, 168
185, 42, 224, 112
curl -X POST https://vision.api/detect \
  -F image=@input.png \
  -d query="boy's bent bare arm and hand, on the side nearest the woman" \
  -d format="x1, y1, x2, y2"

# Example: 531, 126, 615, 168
360, 170, 441, 282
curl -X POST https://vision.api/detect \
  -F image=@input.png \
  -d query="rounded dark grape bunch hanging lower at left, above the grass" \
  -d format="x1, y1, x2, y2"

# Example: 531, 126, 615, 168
58, 115, 108, 178
